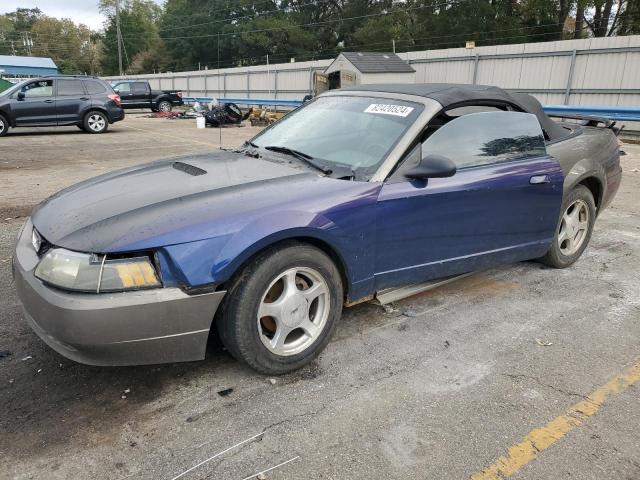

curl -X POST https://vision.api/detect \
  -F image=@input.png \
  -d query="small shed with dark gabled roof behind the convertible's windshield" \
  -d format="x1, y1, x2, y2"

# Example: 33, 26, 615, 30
324, 52, 416, 89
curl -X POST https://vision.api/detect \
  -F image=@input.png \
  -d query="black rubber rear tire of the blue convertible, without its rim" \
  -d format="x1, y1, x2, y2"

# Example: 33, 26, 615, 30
539, 185, 596, 268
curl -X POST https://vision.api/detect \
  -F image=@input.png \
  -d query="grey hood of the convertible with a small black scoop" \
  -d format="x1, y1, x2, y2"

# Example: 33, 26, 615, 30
32, 152, 312, 253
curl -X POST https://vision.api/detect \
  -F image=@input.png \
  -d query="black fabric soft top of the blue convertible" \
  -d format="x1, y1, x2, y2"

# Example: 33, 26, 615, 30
341, 83, 568, 140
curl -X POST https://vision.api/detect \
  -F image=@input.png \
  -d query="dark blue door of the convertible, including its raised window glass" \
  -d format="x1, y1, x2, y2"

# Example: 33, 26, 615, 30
375, 111, 564, 289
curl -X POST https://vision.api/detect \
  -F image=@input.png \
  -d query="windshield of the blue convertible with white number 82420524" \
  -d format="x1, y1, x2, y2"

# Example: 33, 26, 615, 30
252, 96, 423, 178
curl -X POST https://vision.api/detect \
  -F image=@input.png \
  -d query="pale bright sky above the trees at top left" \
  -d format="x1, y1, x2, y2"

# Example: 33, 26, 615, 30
0, 0, 163, 30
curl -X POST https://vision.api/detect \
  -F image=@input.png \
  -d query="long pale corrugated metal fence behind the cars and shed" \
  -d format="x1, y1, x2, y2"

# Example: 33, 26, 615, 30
107, 35, 640, 111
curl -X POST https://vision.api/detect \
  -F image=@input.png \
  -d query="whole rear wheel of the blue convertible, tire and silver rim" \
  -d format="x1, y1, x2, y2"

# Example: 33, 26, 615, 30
540, 185, 596, 268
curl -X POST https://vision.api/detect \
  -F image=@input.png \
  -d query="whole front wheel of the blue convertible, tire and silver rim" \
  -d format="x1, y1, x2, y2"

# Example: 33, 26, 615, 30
217, 243, 343, 375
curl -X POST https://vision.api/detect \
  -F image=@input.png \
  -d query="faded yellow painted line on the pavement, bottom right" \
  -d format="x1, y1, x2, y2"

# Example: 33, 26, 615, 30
471, 359, 640, 480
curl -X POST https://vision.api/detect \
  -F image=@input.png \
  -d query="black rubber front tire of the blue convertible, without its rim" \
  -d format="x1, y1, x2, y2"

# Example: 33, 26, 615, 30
216, 242, 343, 375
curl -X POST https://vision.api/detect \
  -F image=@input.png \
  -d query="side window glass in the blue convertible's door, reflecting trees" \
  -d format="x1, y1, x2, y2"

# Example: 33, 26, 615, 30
422, 112, 546, 168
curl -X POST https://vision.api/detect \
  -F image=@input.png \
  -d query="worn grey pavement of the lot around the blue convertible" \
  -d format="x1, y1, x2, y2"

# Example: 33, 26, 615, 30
0, 115, 640, 480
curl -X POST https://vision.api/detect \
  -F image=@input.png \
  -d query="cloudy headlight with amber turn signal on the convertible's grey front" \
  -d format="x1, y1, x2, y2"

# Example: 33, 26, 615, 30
35, 248, 161, 293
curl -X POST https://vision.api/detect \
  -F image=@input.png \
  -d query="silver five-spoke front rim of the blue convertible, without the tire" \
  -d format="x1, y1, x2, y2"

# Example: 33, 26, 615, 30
257, 267, 331, 356
